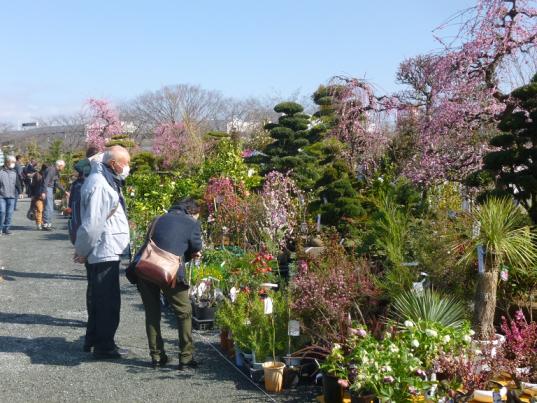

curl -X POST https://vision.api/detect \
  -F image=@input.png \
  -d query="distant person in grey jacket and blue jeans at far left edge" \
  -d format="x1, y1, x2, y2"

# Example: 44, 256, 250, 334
0, 155, 22, 235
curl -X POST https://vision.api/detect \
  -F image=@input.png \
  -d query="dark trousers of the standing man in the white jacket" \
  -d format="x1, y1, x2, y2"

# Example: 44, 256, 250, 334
84, 261, 121, 351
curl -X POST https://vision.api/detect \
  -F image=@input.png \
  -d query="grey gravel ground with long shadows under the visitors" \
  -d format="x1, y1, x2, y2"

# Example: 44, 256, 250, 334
0, 200, 310, 402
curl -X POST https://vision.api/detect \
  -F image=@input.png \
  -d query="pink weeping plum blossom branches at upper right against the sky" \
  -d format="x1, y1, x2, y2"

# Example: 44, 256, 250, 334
336, 0, 537, 185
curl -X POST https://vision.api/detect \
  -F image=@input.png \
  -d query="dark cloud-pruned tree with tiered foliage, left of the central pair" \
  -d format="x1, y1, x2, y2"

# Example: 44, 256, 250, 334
250, 102, 318, 189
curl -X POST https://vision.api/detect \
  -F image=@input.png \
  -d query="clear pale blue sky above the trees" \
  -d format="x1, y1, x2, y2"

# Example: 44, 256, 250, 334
0, 0, 475, 123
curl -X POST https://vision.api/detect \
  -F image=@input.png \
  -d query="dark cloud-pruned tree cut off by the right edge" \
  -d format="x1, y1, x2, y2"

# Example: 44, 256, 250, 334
481, 74, 537, 224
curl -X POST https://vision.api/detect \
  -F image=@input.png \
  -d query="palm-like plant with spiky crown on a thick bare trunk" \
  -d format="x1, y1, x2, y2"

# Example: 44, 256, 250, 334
456, 198, 537, 339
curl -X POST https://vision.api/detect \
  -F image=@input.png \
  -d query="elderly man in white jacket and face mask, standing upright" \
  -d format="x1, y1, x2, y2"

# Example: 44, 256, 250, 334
74, 146, 130, 359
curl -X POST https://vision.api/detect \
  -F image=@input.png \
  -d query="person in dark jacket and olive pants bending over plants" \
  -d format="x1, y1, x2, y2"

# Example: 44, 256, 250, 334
138, 199, 202, 370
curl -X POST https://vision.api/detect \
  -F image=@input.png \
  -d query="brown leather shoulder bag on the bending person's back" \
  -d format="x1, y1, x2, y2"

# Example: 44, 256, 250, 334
135, 217, 182, 288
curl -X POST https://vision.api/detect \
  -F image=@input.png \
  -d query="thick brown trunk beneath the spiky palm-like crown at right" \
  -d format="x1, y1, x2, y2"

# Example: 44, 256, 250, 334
473, 269, 498, 340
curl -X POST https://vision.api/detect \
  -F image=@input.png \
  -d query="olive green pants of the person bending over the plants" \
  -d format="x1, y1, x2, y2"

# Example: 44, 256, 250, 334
138, 279, 194, 364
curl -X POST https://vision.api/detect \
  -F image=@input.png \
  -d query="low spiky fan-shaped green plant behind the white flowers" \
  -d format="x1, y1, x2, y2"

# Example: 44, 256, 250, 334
392, 289, 466, 328
